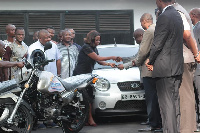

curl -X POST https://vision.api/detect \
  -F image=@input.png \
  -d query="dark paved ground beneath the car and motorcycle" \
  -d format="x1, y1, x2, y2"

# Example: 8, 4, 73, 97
32, 116, 157, 133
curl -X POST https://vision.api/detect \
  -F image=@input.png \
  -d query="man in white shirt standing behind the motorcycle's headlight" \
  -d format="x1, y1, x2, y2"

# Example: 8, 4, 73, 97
28, 30, 61, 75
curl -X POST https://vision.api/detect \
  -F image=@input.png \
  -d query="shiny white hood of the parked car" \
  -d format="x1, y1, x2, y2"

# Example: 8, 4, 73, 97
92, 67, 140, 83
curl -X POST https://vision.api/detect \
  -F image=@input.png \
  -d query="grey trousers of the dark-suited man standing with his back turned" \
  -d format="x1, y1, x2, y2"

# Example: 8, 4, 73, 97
156, 75, 182, 133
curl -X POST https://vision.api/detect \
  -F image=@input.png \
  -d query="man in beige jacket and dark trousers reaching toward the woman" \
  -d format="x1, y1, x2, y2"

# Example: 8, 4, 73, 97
118, 13, 161, 131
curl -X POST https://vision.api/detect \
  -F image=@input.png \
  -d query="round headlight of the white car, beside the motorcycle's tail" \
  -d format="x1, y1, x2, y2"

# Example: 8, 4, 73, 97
95, 78, 110, 91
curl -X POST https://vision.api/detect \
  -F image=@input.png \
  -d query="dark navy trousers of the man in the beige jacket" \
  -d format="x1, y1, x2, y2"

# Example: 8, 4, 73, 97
143, 77, 162, 127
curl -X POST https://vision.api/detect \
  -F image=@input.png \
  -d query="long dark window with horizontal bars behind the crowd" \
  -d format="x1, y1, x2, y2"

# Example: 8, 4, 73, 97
0, 10, 134, 45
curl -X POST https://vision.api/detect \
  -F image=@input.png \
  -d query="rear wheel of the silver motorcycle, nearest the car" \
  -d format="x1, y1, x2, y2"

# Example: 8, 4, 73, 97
61, 90, 89, 133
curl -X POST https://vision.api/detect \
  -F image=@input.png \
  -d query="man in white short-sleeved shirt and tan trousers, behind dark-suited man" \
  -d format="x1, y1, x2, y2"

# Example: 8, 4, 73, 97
172, 0, 199, 133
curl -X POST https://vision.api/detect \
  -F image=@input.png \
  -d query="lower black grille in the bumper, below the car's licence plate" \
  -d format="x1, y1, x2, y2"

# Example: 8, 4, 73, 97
114, 100, 146, 110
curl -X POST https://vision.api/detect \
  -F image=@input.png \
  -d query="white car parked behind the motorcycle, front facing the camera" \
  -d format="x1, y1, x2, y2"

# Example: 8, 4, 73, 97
92, 44, 146, 117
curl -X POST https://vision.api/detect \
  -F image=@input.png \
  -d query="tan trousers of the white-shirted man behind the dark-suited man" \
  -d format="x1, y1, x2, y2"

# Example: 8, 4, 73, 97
179, 63, 196, 133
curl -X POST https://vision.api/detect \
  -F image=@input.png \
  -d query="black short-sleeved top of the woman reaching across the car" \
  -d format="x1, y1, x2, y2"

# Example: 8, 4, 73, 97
73, 44, 99, 75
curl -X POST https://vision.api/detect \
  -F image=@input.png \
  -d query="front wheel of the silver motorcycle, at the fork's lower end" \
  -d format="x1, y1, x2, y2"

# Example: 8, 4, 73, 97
0, 104, 33, 133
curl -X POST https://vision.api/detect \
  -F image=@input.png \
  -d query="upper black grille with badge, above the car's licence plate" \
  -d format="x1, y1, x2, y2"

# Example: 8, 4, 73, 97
117, 81, 143, 91
